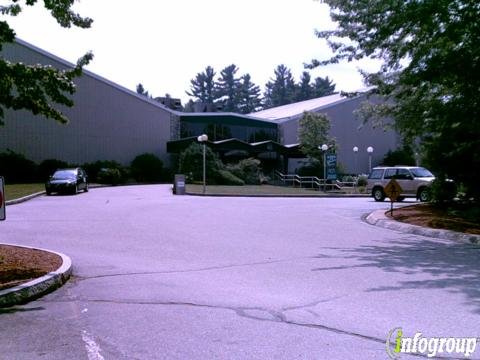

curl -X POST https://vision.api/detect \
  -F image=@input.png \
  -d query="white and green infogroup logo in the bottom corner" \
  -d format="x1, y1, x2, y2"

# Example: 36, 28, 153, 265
386, 327, 478, 359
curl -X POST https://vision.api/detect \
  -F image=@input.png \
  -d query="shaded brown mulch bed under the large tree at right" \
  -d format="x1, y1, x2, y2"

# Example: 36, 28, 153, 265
386, 204, 480, 235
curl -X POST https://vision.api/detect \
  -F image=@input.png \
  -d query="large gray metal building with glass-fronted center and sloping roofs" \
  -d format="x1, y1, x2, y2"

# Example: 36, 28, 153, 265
0, 39, 399, 173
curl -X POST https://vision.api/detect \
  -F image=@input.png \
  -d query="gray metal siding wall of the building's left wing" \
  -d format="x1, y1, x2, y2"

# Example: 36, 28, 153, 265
0, 40, 171, 164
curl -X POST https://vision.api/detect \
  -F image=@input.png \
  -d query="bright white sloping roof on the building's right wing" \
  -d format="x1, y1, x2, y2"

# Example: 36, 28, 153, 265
253, 94, 357, 122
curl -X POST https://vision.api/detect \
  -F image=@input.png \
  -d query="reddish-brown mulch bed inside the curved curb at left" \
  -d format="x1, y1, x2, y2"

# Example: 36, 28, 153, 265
0, 244, 62, 290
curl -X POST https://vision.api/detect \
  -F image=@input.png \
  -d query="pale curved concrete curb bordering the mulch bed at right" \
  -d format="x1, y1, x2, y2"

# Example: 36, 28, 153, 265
365, 210, 480, 245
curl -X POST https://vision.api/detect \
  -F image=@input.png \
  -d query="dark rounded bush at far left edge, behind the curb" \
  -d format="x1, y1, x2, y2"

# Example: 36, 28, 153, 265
0, 150, 38, 184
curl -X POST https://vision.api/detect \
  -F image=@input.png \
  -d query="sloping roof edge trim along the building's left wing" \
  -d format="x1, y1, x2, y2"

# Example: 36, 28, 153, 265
15, 37, 178, 115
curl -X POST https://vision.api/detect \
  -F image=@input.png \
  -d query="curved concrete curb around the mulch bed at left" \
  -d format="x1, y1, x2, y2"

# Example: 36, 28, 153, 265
0, 243, 72, 308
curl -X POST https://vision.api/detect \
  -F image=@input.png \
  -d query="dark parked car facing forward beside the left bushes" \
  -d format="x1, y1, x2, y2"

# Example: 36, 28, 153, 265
45, 168, 88, 195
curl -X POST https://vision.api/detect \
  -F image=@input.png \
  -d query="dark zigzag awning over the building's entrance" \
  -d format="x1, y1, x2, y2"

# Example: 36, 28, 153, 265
167, 136, 305, 158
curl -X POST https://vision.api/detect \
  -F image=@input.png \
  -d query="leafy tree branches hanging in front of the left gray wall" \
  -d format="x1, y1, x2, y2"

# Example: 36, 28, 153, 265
0, 0, 93, 124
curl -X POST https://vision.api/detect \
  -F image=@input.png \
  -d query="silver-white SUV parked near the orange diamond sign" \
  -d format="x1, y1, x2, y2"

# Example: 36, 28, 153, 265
367, 166, 435, 201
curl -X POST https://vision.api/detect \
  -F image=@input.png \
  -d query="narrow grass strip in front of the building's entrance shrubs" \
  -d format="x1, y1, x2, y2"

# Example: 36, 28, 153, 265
186, 184, 366, 196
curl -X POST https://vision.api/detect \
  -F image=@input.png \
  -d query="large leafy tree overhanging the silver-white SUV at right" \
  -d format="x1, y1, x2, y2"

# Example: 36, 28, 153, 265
311, 0, 480, 200
